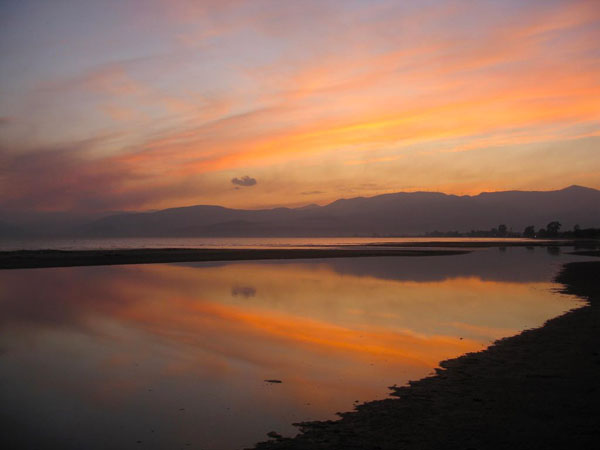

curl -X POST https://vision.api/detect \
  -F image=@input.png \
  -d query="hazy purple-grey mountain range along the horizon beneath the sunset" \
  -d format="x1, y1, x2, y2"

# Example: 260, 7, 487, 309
71, 186, 600, 237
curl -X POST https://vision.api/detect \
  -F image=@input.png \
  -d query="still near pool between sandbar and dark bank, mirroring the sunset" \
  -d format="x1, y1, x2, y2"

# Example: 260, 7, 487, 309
0, 248, 577, 450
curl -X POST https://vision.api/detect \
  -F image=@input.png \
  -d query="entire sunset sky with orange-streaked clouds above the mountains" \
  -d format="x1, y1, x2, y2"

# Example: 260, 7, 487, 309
0, 0, 600, 211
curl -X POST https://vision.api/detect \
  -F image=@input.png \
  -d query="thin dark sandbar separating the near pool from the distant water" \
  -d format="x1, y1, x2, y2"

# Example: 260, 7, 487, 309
0, 248, 468, 269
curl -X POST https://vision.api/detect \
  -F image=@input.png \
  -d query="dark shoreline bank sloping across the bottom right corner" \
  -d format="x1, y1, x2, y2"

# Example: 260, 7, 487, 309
251, 262, 600, 450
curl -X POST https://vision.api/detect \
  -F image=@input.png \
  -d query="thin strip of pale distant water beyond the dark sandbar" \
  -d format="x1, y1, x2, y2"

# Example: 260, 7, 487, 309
0, 237, 527, 251
